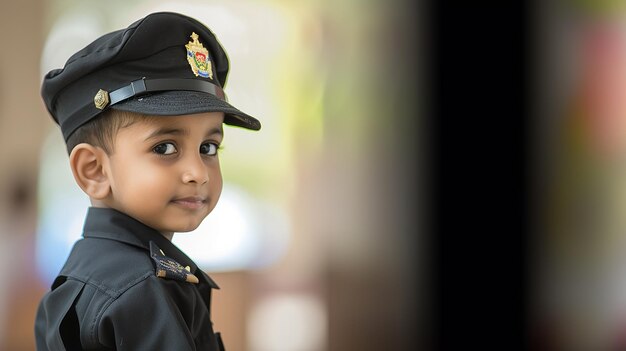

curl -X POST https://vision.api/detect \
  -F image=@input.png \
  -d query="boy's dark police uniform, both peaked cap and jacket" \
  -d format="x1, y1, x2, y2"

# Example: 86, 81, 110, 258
35, 13, 261, 350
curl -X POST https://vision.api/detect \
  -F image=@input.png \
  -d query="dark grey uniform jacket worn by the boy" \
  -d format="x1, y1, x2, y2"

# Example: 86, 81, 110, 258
35, 208, 223, 351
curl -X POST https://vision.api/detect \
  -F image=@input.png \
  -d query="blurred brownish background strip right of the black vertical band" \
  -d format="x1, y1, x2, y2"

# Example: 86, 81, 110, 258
528, 0, 626, 350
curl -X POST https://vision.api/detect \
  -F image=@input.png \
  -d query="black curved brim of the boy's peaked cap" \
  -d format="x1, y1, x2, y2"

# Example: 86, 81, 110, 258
111, 90, 261, 130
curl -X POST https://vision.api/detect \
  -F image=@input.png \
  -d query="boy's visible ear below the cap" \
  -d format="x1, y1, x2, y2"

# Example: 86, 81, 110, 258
70, 143, 111, 200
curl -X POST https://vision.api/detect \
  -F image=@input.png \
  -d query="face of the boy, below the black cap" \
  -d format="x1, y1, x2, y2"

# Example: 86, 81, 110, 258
105, 112, 224, 234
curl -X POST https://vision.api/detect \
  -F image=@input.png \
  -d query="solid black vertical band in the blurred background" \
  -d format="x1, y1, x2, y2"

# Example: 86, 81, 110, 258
428, 0, 532, 350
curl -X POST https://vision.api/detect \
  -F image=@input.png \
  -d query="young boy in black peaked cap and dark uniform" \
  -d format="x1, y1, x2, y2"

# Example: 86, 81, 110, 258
35, 13, 261, 350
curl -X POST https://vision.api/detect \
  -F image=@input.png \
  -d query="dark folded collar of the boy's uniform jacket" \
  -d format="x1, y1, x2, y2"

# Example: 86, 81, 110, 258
83, 207, 219, 289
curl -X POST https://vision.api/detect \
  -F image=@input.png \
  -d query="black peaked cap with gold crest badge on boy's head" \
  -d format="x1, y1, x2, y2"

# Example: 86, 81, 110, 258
41, 12, 261, 141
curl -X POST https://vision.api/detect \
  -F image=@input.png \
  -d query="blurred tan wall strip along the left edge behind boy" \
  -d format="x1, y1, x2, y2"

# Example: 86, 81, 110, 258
0, 0, 52, 351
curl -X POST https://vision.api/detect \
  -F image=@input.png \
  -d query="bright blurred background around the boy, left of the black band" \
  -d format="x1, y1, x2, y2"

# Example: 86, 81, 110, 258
0, 0, 420, 351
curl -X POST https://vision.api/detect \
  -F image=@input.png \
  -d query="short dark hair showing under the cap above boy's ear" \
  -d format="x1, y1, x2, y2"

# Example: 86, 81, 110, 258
66, 109, 151, 155
